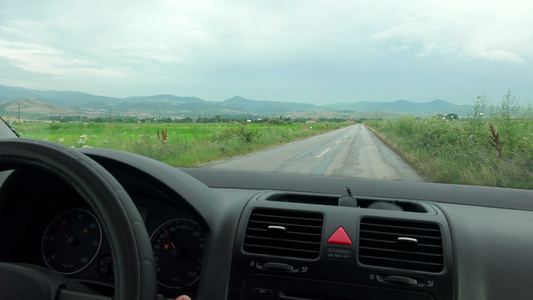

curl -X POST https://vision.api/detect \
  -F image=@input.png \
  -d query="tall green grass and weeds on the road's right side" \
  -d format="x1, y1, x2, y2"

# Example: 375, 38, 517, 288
366, 91, 533, 189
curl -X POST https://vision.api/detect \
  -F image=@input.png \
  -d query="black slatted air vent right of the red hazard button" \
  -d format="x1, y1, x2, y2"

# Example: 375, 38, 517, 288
359, 218, 443, 272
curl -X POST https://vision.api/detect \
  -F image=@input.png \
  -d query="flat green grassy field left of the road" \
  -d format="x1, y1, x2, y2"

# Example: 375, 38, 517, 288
15, 122, 350, 167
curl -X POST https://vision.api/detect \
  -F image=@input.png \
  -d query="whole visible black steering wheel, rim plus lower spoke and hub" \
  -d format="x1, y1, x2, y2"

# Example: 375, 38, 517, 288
0, 139, 157, 300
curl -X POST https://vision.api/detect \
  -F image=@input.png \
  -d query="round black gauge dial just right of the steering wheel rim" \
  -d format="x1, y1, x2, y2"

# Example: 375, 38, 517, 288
150, 219, 205, 289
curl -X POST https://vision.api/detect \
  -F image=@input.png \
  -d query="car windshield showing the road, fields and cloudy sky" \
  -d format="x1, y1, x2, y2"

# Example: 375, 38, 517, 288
0, 0, 533, 189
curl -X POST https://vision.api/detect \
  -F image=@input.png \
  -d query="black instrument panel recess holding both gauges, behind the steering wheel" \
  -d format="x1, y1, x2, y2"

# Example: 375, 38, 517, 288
0, 163, 206, 297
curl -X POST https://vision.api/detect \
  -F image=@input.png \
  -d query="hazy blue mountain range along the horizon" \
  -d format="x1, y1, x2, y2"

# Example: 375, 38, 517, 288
0, 85, 467, 117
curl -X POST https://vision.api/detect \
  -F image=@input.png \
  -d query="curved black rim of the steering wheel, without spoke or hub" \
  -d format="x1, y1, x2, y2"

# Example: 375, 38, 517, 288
0, 139, 157, 300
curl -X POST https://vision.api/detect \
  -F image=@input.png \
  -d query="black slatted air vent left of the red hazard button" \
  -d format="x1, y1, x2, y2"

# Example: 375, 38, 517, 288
244, 209, 324, 259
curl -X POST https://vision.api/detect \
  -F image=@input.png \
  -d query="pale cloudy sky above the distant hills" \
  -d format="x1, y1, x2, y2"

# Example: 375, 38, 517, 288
0, 0, 533, 105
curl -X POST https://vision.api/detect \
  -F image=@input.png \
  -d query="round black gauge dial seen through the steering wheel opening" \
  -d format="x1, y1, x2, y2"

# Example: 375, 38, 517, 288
41, 208, 102, 275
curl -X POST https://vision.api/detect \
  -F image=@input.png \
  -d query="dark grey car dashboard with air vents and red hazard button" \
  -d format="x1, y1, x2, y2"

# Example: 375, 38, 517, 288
0, 141, 533, 300
